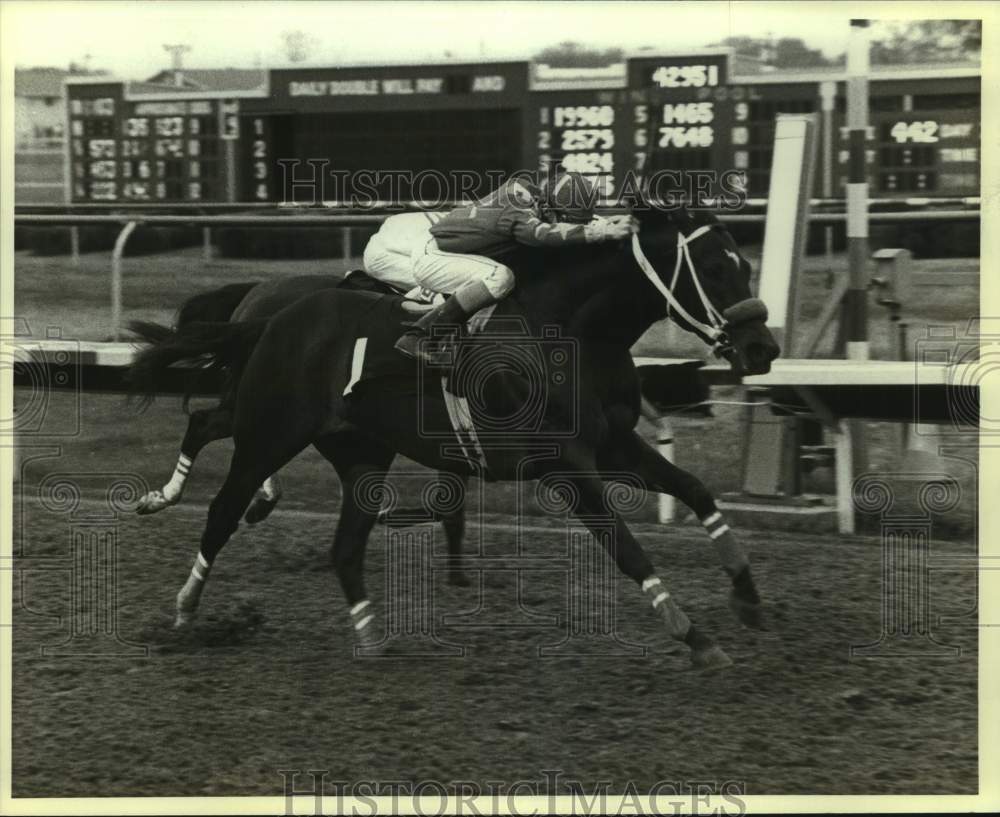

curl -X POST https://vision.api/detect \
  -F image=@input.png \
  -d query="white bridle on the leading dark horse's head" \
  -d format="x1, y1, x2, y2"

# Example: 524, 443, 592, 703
632, 224, 767, 355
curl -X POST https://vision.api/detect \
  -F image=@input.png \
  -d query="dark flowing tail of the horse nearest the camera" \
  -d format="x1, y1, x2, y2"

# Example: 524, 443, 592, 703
128, 318, 267, 408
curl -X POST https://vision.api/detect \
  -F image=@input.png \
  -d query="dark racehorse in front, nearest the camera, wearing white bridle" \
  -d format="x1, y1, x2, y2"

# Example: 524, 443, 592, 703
127, 207, 779, 667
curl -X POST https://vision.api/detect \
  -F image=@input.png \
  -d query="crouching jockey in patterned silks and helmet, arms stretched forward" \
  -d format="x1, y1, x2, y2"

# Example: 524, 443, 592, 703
396, 173, 633, 359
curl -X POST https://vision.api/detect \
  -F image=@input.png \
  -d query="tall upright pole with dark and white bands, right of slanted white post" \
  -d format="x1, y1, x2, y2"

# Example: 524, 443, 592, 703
844, 20, 869, 360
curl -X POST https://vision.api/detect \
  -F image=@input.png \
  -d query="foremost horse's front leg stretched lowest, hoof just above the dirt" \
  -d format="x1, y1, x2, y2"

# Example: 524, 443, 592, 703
562, 466, 732, 669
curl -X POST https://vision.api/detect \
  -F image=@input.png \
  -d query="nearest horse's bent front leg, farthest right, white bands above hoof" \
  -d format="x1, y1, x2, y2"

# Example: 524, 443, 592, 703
602, 431, 762, 629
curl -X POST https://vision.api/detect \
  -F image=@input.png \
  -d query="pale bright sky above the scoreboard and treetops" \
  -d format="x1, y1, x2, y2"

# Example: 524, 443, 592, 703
0, 0, 960, 79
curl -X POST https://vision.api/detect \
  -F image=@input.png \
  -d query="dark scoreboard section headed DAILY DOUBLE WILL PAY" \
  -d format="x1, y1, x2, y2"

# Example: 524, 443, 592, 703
237, 62, 528, 204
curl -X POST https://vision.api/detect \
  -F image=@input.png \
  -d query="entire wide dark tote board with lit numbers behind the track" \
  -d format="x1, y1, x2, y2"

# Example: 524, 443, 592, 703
66, 57, 981, 203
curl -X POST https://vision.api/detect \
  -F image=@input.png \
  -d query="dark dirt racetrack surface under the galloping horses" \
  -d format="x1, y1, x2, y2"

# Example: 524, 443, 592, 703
12, 429, 978, 797
